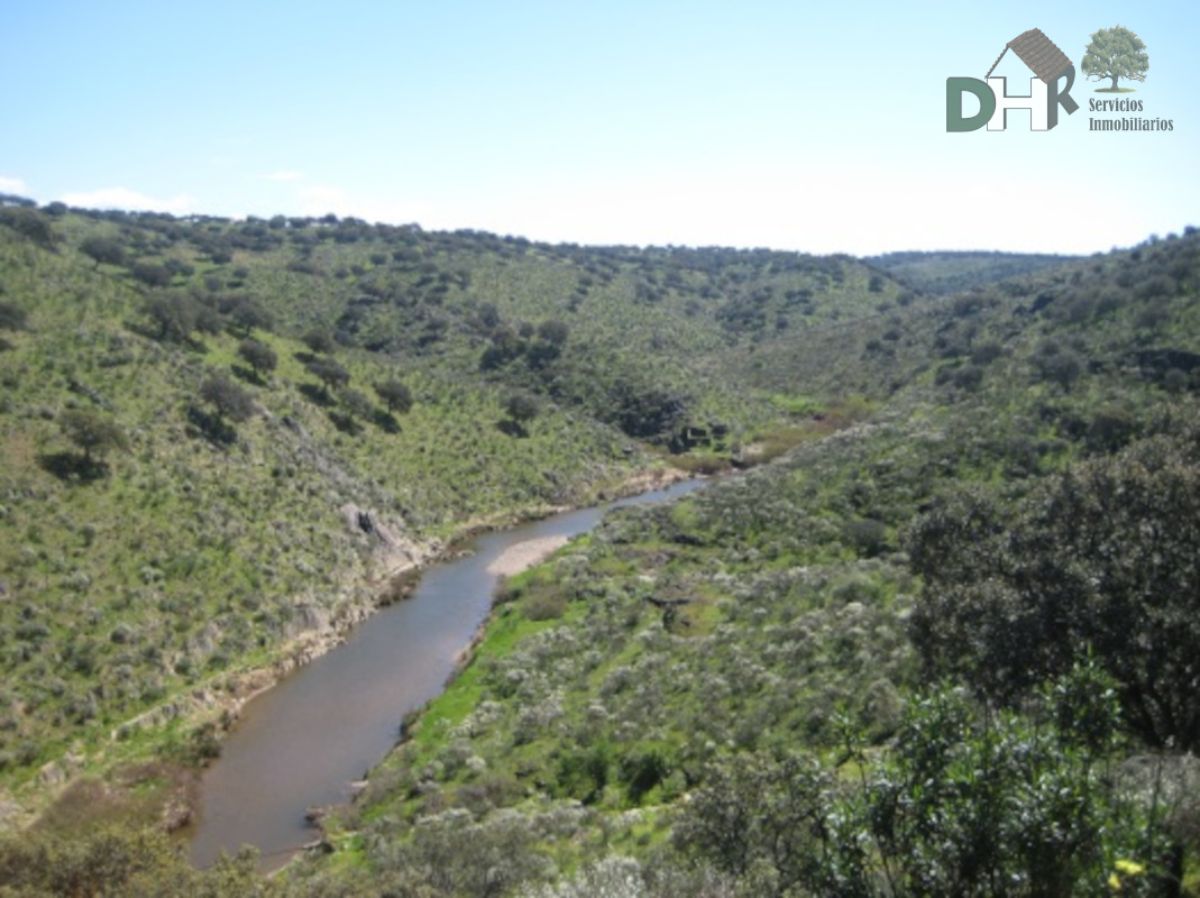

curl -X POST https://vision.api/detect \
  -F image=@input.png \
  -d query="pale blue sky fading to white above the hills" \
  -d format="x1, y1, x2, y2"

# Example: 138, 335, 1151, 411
0, 0, 1200, 255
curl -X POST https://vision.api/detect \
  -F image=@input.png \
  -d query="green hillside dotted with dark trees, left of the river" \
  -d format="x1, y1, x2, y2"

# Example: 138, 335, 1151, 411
0, 200, 896, 819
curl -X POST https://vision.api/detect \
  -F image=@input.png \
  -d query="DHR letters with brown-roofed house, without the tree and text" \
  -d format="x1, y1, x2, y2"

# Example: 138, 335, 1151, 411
946, 28, 1079, 131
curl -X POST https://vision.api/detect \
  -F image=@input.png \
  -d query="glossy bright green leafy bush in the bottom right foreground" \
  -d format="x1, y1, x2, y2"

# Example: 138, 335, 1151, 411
673, 666, 1178, 898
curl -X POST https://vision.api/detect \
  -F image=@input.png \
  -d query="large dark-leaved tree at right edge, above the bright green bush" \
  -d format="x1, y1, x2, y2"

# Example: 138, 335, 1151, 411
908, 427, 1200, 750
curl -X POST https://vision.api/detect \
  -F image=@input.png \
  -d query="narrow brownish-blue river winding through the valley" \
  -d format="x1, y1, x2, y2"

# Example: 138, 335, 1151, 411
191, 480, 703, 869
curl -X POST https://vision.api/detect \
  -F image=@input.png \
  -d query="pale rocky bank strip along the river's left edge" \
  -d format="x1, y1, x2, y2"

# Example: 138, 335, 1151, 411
7, 465, 688, 834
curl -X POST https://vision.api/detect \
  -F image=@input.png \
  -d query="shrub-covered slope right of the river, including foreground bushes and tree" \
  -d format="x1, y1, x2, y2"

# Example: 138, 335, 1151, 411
278, 233, 1200, 896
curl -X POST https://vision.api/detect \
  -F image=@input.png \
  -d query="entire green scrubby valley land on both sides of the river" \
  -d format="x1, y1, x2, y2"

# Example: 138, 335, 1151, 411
0, 198, 1200, 898
